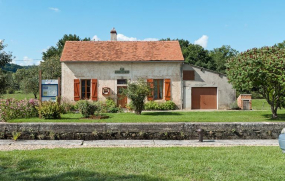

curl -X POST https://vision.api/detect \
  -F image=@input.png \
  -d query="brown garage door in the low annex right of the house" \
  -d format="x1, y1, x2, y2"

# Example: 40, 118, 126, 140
191, 87, 217, 109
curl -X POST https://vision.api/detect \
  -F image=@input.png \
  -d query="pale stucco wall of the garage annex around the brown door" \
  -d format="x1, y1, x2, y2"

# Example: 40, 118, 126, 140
183, 64, 236, 109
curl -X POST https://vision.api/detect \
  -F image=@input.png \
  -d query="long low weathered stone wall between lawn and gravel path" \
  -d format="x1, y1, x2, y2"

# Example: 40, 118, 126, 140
0, 122, 285, 140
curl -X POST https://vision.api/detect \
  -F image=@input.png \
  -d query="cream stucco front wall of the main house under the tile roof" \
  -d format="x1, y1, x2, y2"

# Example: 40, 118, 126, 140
61, 62, 182, 108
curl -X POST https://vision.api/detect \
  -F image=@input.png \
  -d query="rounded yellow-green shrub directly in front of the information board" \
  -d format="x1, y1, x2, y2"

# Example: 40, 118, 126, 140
37, 101, 64, 119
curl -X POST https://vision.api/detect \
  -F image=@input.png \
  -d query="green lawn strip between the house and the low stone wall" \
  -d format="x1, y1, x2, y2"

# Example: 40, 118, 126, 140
8, 110, 285, 123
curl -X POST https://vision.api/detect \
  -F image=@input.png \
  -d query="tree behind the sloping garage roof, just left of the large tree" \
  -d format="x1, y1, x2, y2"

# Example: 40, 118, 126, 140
210, 45, 238, 73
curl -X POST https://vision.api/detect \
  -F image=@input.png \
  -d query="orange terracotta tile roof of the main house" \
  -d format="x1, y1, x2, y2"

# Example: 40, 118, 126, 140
60, 41, 184, 62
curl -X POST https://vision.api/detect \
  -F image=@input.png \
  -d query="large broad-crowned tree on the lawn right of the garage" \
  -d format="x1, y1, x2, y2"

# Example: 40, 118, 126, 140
226, 46, 285, 118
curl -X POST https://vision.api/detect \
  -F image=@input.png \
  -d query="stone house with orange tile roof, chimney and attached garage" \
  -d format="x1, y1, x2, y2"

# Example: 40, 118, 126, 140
60, 29, 235, 109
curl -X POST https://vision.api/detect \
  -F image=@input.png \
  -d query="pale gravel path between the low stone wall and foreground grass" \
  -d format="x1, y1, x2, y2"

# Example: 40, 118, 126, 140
0, 140, 279, 151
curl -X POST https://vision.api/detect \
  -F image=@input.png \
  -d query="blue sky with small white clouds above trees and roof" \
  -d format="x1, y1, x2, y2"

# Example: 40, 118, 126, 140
0, 0, 285, 65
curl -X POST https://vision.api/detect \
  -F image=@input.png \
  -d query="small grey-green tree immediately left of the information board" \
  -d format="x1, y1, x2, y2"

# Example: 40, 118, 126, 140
15, 66, 39, 99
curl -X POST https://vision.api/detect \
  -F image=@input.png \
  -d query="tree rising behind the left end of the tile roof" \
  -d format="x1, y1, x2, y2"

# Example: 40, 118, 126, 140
40, 34, 90, 79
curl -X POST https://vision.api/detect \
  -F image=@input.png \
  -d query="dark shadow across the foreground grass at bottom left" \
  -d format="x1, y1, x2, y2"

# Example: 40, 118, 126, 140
0, 157, 167, 181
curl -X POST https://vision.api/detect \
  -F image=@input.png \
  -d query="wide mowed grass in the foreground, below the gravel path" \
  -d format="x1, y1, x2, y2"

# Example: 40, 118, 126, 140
0, 147, 285, 181
